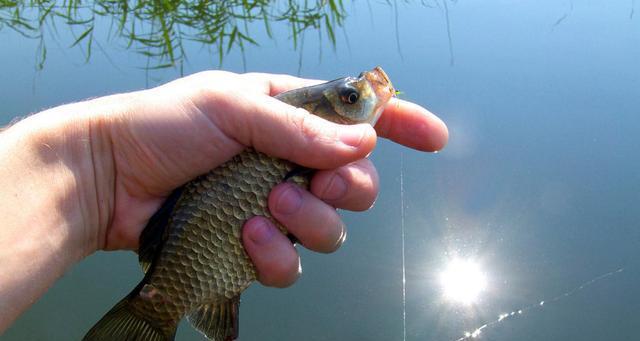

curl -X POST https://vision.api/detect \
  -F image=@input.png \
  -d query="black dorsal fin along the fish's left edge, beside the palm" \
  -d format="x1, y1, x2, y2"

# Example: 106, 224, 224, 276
138, 186, 184, 273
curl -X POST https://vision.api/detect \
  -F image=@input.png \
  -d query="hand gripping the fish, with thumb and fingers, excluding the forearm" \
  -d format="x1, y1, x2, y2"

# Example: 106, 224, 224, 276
92, 72, 447, 287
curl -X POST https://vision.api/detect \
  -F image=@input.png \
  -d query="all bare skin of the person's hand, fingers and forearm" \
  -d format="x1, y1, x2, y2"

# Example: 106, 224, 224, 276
0, 71, 448, 333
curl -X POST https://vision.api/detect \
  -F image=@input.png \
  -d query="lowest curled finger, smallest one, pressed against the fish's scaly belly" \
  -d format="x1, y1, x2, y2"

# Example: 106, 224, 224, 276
242, 217, 300, 288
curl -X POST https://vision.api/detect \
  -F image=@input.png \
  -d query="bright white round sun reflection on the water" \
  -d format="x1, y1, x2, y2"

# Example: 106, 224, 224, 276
440, 259, 487, 305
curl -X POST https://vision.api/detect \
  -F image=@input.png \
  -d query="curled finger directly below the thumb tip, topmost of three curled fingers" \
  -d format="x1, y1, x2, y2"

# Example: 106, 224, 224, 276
311, 159, 379, 211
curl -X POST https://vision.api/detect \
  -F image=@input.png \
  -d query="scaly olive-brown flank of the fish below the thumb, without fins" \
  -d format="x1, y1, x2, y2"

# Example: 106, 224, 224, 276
131, 149, 308, 334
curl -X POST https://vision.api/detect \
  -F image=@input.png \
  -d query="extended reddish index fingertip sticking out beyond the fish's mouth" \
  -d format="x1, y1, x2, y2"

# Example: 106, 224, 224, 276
376, 98, 449, 151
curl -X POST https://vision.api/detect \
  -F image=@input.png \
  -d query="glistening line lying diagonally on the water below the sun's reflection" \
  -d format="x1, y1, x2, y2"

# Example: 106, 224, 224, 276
455, 268, 625, 341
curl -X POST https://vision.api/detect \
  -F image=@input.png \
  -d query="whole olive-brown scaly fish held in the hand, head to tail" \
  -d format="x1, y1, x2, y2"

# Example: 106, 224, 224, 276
83, 67, 395, 341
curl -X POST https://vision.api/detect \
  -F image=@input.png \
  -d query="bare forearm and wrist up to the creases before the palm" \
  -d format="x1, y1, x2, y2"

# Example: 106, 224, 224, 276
0, 92, 140, 333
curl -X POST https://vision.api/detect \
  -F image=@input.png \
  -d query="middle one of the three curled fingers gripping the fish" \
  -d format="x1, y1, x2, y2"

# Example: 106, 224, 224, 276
269, 183, 346, 253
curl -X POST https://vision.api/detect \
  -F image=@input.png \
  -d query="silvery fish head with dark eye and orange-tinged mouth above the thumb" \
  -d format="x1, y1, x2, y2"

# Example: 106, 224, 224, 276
321, 66, 395, 125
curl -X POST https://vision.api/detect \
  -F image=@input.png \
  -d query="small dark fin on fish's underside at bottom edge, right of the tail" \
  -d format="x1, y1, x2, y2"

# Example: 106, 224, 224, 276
188, 295, 240, 341
